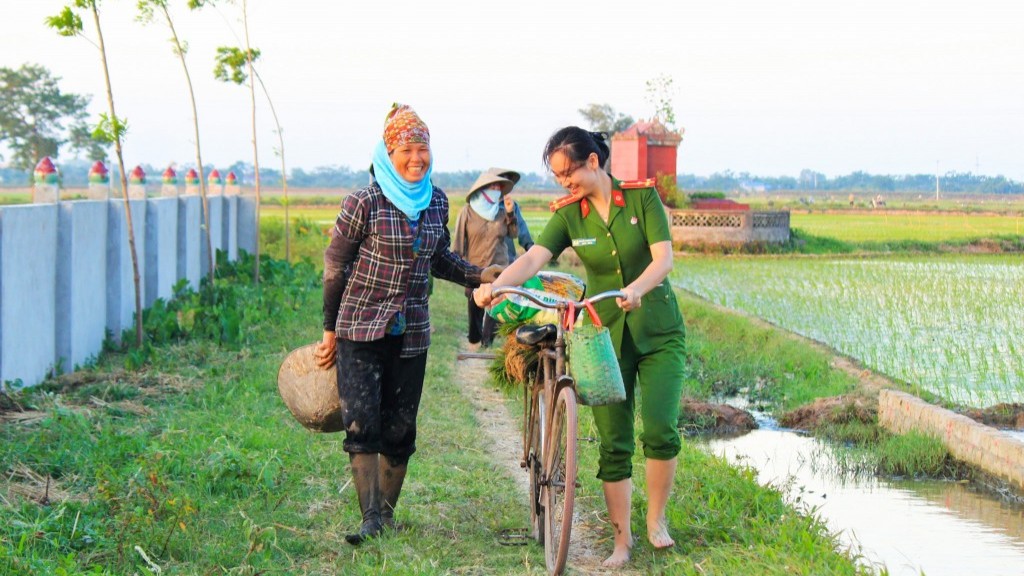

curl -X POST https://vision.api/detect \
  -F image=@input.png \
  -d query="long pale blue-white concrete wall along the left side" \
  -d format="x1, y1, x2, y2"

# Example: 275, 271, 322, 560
0, 197, 256, 385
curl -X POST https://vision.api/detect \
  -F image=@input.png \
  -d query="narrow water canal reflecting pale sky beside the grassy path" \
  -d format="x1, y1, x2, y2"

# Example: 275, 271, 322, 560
706, 414, 1024, 576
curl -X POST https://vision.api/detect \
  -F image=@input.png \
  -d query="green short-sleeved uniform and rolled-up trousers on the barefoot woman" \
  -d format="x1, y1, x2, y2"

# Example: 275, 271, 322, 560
537, 178, 686, 482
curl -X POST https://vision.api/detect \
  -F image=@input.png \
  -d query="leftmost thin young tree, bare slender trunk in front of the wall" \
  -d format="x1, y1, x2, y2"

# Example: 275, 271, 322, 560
46, 0, 142, 347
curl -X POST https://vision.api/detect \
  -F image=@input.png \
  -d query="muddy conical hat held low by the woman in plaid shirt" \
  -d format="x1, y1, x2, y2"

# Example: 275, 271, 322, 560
278, 344, 345, 433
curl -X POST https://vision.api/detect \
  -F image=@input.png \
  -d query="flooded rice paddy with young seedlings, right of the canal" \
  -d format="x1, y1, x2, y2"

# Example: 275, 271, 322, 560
672, 255, 1024, 407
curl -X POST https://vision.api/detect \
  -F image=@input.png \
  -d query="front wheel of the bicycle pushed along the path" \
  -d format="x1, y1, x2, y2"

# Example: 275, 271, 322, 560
544, 386, 577, 574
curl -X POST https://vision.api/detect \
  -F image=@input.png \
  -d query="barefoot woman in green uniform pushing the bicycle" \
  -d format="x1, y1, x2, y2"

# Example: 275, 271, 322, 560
475, 126, 685, 567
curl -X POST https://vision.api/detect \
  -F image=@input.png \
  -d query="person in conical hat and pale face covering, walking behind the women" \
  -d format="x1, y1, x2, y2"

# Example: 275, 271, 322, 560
452, 168, 517, 348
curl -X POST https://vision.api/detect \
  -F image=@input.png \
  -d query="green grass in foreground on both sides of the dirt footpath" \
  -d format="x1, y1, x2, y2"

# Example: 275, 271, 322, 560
0, 252, 872, 575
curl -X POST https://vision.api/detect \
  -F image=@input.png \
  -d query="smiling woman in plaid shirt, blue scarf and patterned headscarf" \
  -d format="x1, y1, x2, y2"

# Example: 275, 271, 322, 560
316, 105, 500, 544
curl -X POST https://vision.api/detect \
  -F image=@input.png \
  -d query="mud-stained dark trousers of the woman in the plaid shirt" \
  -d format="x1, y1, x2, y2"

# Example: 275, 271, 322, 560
337, 336, 427, 465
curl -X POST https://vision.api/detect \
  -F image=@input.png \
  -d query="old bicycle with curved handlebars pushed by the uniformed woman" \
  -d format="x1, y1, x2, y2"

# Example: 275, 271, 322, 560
493, 286, 626, 575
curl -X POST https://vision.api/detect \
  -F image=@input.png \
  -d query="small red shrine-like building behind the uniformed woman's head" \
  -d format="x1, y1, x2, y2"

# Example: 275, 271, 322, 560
611, 118, 684, 183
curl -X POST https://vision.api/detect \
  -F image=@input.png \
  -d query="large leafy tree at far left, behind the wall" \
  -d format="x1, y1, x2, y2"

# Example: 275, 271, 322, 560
0, 64, 102, 172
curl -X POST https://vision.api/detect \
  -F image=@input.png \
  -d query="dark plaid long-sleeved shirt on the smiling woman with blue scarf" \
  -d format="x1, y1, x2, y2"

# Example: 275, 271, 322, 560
324, 182, 481, 358
